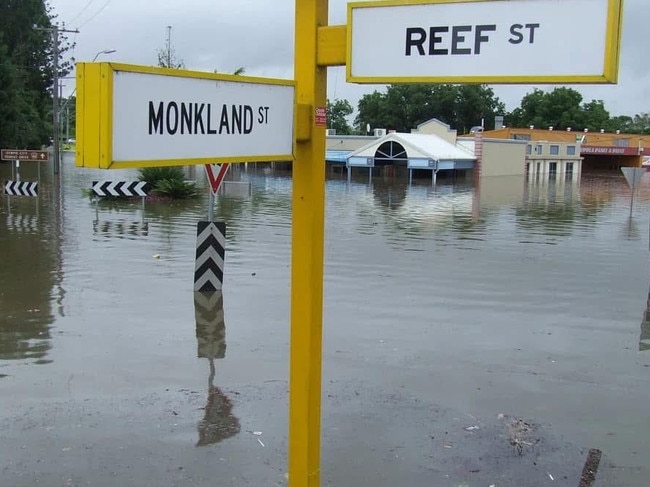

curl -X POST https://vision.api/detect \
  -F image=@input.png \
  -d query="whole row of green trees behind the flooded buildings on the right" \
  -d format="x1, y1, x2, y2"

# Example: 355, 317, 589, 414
327, 83, 650, 135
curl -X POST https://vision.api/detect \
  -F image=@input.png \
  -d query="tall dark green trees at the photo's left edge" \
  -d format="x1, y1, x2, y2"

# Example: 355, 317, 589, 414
0, 0, 72, 149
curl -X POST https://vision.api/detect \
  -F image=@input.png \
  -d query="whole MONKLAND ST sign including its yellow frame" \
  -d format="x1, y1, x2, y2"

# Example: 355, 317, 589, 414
76, 63, 294, 169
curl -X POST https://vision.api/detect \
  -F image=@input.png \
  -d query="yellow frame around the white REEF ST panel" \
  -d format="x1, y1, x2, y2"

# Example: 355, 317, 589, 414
345, 0, 623, 84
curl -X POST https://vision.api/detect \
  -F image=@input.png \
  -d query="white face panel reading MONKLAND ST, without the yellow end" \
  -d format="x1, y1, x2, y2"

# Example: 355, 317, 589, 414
111, 66, 294, 164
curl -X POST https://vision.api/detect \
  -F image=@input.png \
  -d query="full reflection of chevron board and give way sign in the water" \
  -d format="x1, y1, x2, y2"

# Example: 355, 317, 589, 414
194, 291, 240, 446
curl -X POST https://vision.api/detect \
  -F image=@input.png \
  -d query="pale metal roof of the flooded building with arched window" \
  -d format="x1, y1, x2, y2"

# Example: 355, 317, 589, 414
348, 133, 476, 161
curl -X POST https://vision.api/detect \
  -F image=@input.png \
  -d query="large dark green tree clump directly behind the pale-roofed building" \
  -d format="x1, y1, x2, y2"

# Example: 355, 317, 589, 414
355, 83, 505, 132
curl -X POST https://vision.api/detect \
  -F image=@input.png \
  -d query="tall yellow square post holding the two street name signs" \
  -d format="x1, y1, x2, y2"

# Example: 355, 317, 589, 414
289, 0, 328, 487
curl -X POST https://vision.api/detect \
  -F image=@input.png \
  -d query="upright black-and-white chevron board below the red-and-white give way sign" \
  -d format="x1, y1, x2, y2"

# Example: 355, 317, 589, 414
194, 222, 226, 292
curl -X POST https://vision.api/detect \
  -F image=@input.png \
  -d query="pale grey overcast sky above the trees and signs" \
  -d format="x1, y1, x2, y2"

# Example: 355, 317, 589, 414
50, 0, 650, 121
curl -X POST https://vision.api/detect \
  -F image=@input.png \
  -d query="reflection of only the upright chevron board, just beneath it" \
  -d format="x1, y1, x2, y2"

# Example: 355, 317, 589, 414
194, 291, 226, 359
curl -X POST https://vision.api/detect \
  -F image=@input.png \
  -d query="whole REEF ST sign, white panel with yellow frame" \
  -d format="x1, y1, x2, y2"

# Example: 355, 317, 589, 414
346, 0, 622, 83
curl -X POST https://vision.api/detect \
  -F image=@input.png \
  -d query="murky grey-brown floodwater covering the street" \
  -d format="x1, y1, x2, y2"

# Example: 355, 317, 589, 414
0, 154, 650, 487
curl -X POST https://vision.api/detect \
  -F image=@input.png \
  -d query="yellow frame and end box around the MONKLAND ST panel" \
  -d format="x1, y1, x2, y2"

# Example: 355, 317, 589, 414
76, 63, 295, 169
